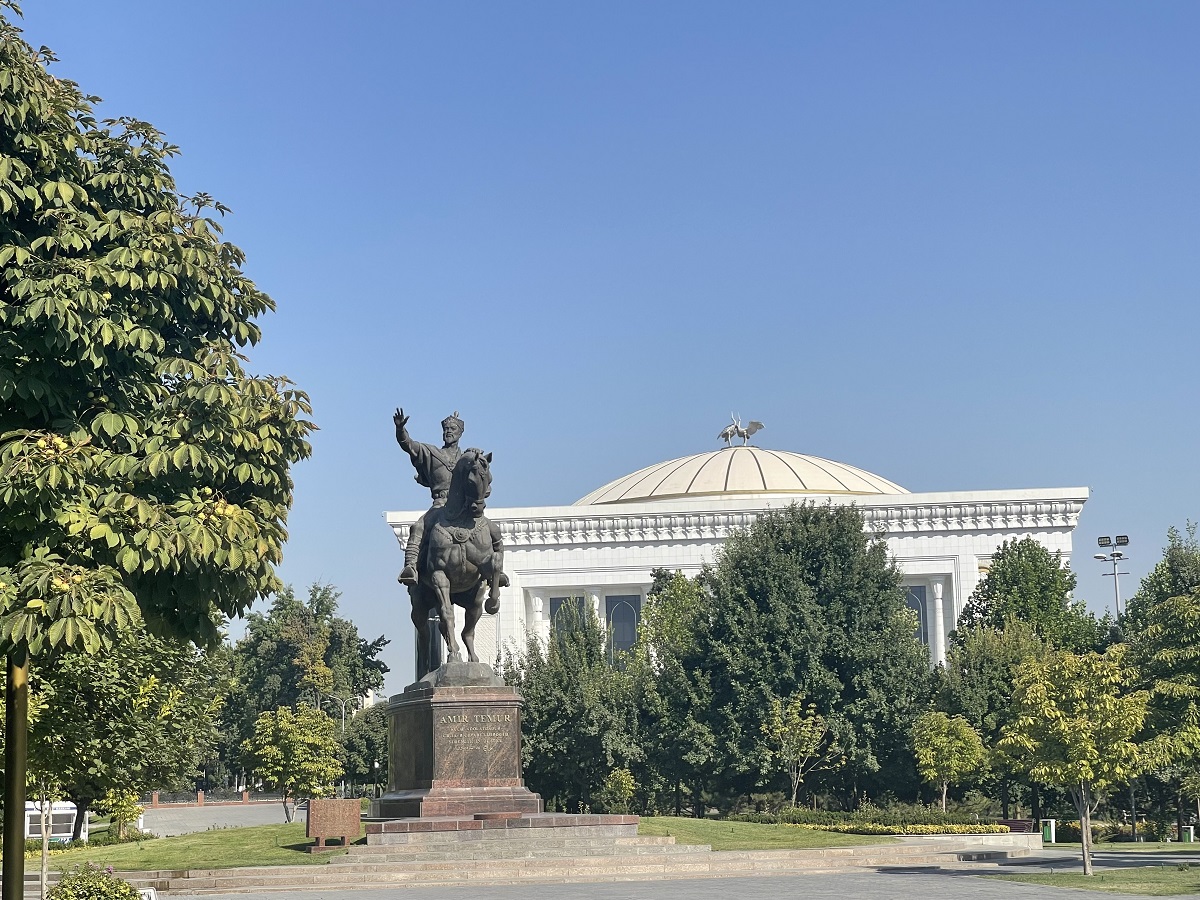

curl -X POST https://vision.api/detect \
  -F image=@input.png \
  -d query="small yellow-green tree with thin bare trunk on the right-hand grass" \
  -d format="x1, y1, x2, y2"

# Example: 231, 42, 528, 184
1000, 644, 1175, 875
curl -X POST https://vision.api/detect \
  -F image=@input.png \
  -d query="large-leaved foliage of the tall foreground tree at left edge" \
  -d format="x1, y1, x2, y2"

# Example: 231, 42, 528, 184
0, 5, 313, 656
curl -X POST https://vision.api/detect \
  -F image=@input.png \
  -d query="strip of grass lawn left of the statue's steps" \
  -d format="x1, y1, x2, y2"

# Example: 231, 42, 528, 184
25, 822, 365, 871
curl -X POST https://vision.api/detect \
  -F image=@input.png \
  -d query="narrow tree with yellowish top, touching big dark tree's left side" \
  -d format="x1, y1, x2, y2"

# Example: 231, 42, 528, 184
626, 569, 716, 817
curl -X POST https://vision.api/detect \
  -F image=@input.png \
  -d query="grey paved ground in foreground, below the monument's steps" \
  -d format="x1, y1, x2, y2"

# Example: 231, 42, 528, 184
184, 871, 1161, 900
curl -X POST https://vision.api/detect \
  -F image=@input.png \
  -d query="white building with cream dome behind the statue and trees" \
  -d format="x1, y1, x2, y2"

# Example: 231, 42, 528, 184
386, 446, 1087, 664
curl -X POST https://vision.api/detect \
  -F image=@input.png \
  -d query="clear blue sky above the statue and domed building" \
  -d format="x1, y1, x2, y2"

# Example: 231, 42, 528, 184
24, 0, 1200, 690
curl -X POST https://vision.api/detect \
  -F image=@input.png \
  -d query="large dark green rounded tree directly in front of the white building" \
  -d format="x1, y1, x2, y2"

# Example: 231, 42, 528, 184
696, 504, 931, 803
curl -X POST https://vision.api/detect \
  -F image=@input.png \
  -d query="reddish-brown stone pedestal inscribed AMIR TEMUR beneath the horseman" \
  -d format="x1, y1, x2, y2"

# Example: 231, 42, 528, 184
371, 662, 542, 818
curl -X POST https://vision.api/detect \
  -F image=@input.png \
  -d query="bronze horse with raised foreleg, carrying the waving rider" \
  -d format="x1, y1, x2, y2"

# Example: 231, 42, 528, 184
408, 449, 509, 678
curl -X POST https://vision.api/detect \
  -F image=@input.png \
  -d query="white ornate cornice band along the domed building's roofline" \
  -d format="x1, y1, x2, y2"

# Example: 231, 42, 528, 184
389, 498, 1084, 548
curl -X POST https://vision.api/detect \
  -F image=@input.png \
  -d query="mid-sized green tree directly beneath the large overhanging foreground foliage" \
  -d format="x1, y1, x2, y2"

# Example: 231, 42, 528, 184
30, 629, 228, 838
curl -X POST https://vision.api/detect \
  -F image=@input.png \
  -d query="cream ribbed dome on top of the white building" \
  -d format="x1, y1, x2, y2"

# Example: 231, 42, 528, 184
575, 446, 908, 506
